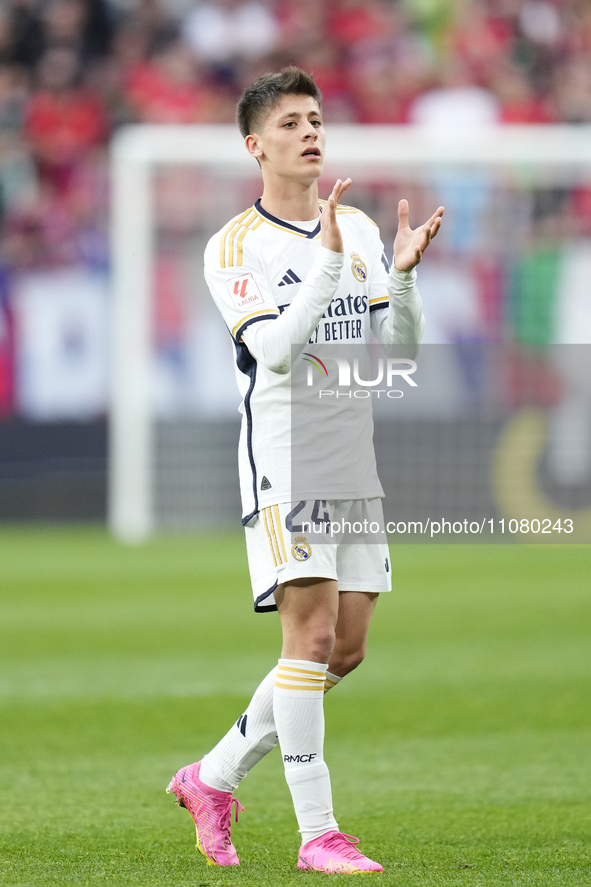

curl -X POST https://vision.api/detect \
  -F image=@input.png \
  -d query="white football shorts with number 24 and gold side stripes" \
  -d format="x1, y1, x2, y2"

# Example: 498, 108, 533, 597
245, 498, 392, 613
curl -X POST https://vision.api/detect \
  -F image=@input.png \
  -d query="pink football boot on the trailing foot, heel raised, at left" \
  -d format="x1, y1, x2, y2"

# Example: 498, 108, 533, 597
166, 761, 244, 865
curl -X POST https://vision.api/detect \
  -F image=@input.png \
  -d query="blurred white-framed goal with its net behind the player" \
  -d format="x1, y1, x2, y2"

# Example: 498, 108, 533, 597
109, 126, 591, 542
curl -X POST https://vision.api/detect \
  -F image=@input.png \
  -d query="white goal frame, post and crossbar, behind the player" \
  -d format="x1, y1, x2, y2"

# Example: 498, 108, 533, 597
108, 125, 591, 542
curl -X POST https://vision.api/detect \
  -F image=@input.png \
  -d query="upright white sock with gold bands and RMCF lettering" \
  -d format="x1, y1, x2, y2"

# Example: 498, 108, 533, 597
273, 659, 339, 844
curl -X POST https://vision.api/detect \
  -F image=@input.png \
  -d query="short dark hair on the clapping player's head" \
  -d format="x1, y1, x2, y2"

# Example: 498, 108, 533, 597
236, 65, 322, 138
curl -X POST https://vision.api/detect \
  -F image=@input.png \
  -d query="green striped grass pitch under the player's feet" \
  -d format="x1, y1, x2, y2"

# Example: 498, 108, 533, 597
0, 528, 591, 887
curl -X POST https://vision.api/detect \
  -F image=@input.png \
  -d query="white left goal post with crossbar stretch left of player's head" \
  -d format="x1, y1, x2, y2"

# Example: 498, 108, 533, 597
107, 126, 250, 542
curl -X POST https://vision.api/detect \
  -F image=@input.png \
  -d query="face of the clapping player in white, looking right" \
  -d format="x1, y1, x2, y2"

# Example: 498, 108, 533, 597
253, 95, 326, 183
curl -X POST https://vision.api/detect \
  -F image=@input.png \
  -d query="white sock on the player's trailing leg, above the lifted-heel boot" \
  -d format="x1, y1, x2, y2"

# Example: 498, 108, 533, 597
199, 667, 277, 792
